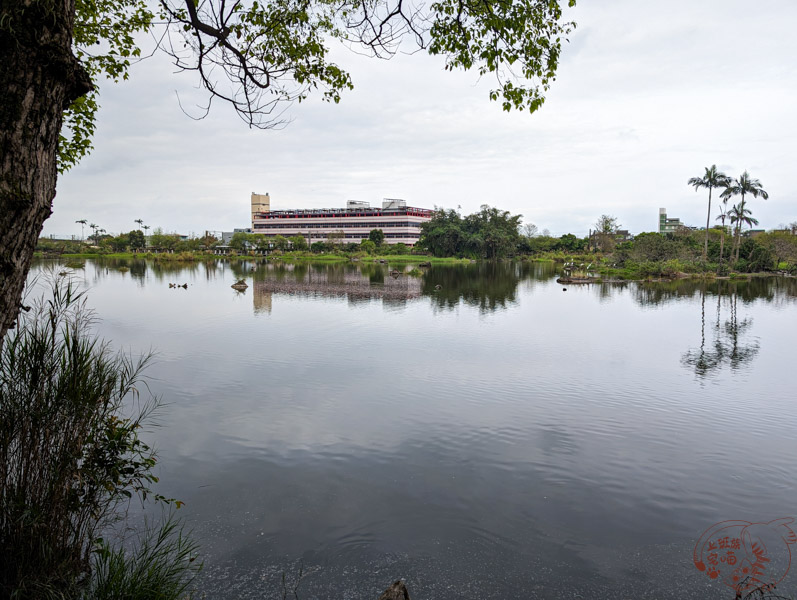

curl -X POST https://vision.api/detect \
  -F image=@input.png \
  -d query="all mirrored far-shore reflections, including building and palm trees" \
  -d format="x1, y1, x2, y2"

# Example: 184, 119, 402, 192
28, 258, 797, 378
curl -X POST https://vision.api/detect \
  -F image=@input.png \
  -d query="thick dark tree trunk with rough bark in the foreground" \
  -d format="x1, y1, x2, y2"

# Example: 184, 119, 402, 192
0, 0, 91, 342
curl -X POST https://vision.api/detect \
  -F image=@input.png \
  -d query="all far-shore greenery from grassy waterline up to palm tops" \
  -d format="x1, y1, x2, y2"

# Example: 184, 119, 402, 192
42, 199, 797, 283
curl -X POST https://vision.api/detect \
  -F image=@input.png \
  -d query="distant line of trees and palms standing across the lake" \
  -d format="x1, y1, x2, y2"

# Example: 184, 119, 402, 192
39, 203, 797, 276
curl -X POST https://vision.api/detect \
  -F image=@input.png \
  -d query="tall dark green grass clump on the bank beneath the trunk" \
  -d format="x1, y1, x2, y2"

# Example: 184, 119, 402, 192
0, 277, 199, 599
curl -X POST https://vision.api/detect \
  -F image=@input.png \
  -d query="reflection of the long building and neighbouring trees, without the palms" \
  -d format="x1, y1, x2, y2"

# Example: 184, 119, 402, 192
34, 258, 560, 314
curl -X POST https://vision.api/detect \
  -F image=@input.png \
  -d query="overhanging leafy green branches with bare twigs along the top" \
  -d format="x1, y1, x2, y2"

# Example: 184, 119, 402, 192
60, 0, 575, 171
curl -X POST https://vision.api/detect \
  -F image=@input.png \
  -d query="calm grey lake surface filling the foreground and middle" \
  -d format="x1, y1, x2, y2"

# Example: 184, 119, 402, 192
32, 261, 797, 600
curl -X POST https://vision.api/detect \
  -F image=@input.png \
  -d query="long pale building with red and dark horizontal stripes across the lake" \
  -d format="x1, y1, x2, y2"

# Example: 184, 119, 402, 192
252, 198, 433, 245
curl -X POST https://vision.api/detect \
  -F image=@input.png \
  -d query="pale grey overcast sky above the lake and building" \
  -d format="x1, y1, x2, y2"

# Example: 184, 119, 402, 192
44, 0, 797, 235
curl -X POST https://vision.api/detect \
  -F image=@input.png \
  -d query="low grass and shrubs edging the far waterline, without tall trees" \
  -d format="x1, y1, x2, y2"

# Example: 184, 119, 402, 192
36, 228, 797, 283
